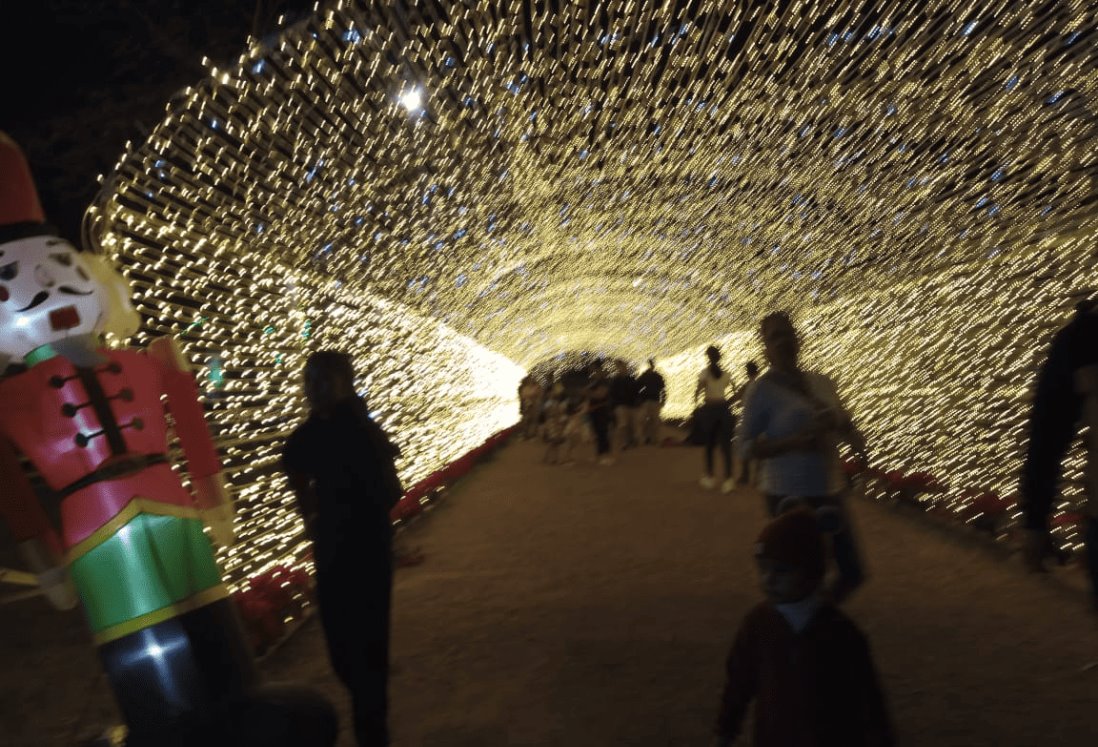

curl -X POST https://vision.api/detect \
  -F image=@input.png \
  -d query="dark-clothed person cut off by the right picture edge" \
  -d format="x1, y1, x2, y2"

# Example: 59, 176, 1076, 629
1021, 300, 1098, 612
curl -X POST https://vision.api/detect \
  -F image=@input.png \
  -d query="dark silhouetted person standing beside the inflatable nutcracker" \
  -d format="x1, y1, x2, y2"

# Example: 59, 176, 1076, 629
282, 350, 403, 746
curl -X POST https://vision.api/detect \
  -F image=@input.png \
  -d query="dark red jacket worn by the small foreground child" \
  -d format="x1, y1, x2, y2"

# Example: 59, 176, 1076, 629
717, 602, 894, 747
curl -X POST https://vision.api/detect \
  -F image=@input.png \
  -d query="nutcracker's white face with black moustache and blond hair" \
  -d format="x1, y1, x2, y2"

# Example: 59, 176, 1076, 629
0, 236, 133, 360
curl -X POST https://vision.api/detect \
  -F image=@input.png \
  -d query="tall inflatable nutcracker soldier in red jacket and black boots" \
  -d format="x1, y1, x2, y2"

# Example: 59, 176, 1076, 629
0, 133, 336, 745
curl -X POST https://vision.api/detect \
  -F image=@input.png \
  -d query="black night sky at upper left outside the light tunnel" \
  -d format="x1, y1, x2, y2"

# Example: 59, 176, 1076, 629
0, 0, 313, 241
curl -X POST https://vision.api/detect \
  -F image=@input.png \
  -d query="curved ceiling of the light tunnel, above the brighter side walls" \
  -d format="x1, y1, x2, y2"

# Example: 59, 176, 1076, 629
98, 0, 1098, 364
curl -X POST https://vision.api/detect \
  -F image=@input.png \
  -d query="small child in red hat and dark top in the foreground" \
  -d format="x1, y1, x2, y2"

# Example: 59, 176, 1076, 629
717, 509, 895, 747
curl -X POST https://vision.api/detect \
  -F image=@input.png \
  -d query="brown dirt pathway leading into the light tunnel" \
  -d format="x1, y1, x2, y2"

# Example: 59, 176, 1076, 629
269, 443, 1098, 747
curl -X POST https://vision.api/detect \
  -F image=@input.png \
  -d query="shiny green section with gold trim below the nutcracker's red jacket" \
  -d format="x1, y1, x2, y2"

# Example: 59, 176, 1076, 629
69, 513, 228, 644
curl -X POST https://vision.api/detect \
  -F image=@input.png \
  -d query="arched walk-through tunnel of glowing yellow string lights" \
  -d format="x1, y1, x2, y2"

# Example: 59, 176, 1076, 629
86, 0, 1098, 581
